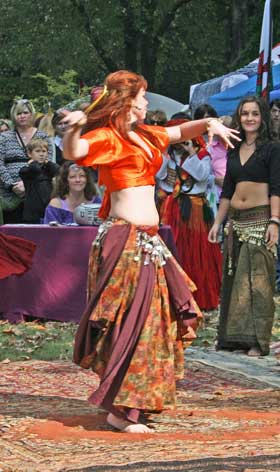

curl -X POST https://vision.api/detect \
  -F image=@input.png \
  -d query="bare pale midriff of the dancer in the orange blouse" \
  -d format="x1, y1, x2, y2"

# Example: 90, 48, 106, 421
110, 185, 159, 226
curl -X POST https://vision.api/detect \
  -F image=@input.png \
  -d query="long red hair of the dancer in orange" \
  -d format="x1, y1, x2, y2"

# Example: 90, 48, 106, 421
83, 70, 158, 146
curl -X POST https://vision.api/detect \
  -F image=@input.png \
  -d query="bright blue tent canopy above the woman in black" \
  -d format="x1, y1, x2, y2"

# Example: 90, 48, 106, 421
207, 64, 280, 116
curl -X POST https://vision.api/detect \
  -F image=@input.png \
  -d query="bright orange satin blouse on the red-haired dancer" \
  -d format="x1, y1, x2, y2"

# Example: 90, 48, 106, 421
77, 121, 169, 218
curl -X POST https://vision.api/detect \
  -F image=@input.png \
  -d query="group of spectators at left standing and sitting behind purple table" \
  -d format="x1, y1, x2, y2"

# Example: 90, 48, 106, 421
0, 99, 102, 224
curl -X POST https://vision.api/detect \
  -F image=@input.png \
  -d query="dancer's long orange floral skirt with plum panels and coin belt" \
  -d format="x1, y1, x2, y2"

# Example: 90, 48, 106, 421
74, 219, 202, 421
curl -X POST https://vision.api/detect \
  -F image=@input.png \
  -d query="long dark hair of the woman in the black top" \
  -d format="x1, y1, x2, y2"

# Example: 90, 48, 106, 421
231, 96, 271, 148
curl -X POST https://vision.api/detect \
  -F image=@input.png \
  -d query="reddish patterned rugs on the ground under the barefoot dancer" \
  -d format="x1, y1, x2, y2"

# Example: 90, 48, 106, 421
0, 361, 280, 472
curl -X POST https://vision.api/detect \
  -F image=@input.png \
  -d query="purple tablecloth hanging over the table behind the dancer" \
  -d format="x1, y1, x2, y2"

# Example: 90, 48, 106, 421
0, 225, 177, 322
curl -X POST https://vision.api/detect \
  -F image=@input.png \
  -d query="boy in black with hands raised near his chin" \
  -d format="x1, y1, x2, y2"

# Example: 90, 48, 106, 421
19, 139, 59, 224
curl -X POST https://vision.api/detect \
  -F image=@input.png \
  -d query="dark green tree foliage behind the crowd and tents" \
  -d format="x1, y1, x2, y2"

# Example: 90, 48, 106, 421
0, 0, 280, 115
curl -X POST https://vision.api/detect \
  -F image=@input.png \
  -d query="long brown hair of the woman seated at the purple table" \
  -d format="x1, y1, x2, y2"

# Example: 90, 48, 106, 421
52, 161, 97, 200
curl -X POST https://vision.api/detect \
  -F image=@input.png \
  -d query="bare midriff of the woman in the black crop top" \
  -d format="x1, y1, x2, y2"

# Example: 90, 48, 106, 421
230, 182, 270, 210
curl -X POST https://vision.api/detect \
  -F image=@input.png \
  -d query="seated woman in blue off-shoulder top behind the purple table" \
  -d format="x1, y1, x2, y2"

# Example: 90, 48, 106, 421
44, 161, 101, 224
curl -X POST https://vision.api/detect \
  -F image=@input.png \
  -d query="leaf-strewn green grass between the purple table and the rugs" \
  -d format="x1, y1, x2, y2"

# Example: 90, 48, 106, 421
0, 297, 280, 362
